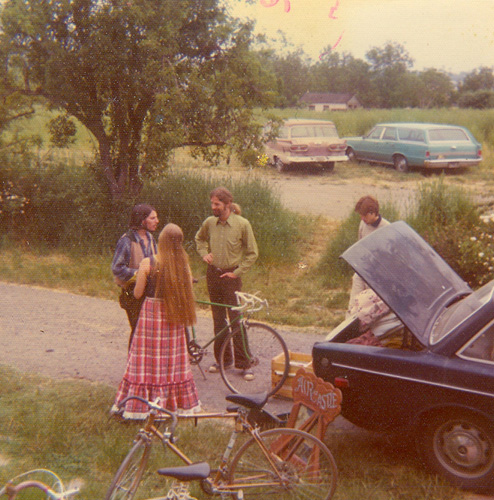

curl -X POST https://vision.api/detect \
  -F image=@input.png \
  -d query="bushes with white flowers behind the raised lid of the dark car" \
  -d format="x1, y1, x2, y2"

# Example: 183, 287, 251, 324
318, 177, 494, 288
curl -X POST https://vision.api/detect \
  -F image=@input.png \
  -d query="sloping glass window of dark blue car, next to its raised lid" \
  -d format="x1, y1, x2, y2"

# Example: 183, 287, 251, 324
430, 283, 493, 344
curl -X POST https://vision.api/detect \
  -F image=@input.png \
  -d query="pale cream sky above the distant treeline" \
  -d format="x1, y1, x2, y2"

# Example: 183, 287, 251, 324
225, 0, 494, 73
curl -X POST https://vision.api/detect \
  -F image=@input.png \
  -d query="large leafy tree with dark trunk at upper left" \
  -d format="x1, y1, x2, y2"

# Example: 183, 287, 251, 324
0, 0, 271, 200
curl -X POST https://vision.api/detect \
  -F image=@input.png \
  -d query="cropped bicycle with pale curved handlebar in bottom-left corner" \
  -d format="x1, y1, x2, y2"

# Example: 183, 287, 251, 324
0, 469, 79, 500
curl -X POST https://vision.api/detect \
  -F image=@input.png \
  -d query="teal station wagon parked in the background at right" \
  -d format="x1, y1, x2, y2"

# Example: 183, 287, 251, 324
345, 123, 482, 172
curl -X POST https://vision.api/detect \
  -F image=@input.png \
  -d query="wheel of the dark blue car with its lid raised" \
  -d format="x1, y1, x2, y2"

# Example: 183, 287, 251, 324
418, 412, 494, 490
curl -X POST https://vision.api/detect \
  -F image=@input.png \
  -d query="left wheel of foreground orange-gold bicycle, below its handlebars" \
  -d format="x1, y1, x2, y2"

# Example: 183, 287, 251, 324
105, 437, 151, 500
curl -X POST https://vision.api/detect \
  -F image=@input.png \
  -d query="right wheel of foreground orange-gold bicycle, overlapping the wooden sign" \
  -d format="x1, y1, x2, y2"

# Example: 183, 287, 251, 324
229, 429, 338, 500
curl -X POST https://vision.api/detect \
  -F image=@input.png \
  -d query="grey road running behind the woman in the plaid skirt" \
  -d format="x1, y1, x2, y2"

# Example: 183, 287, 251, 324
0, 282, 322, 411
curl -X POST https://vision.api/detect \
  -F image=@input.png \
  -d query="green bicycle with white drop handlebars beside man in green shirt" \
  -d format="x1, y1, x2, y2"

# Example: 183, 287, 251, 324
186, 292, 290, 396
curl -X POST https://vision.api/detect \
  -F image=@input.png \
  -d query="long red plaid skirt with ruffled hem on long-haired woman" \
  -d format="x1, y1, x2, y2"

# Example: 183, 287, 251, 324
112, 297, 199, 419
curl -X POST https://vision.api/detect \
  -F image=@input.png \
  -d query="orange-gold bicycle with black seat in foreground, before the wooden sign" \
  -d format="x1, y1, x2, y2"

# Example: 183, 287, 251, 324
105, 393, 338, 500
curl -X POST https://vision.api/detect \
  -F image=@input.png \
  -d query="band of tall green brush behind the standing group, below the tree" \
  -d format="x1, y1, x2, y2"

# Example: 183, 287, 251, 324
0, 161, 298, 262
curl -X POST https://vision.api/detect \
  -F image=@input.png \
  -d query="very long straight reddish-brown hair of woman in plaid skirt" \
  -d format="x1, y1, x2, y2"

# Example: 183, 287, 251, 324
155, 224, 196, 326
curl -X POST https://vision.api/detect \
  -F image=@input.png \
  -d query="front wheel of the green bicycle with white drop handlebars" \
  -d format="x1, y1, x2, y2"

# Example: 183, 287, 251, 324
220, 322, 290, 396
